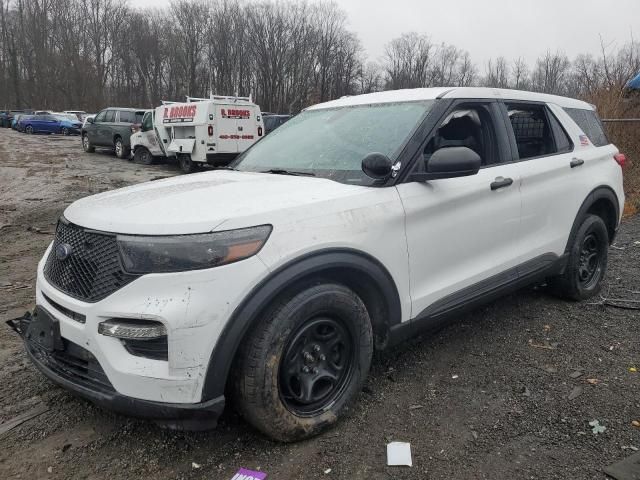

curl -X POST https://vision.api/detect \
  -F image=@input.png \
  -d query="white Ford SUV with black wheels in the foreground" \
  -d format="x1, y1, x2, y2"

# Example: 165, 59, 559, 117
14, 88, 624, 441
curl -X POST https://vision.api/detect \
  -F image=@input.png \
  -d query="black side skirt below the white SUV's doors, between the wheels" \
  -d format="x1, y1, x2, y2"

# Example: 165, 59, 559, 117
389, 253, 567, 346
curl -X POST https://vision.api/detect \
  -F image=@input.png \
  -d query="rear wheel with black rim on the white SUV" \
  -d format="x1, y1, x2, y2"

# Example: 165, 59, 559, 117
549, 215, 609, 300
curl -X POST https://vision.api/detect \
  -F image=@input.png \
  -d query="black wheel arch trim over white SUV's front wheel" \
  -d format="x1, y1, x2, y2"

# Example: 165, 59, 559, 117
202, 249, 401, 401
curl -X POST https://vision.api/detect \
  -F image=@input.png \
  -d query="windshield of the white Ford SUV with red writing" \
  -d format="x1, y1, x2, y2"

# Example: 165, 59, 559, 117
235, 100, 434, 185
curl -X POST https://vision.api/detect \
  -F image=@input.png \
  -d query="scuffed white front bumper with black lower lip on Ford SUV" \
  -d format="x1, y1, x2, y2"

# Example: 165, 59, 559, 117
11, 247, 266, 429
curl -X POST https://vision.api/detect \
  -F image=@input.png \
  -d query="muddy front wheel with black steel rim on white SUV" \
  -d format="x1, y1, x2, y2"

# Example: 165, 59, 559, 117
234, 283, 373, 442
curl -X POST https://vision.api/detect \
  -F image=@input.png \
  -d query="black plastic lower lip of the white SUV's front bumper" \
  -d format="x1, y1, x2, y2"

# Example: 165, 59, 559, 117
8, 314, 225, 430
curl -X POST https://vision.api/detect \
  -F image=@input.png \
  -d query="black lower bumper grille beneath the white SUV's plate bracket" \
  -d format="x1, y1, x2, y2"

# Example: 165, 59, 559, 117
27, 338, 115, 393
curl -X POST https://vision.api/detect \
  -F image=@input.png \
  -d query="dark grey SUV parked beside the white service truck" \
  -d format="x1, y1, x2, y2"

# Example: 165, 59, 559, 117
81, 107, 146, 158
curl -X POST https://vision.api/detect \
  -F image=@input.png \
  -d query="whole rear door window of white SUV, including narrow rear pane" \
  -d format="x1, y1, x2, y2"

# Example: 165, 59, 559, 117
506, 103, 573, 160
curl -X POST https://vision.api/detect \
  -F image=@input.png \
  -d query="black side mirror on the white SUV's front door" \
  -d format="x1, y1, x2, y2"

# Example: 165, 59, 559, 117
410, 147, 482, 182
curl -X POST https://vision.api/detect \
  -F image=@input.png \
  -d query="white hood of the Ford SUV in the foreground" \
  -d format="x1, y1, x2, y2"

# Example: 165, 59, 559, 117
64, 170, 369, 235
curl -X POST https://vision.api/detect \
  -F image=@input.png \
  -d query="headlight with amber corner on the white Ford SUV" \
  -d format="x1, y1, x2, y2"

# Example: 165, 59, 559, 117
118, 225, 272, 274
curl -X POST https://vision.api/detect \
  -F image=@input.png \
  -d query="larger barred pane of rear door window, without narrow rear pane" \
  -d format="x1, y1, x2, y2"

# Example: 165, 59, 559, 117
507, 104, 557, 160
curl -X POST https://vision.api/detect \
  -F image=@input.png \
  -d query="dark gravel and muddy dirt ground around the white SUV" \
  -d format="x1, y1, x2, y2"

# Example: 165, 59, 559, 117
0, 130, 640, 480
